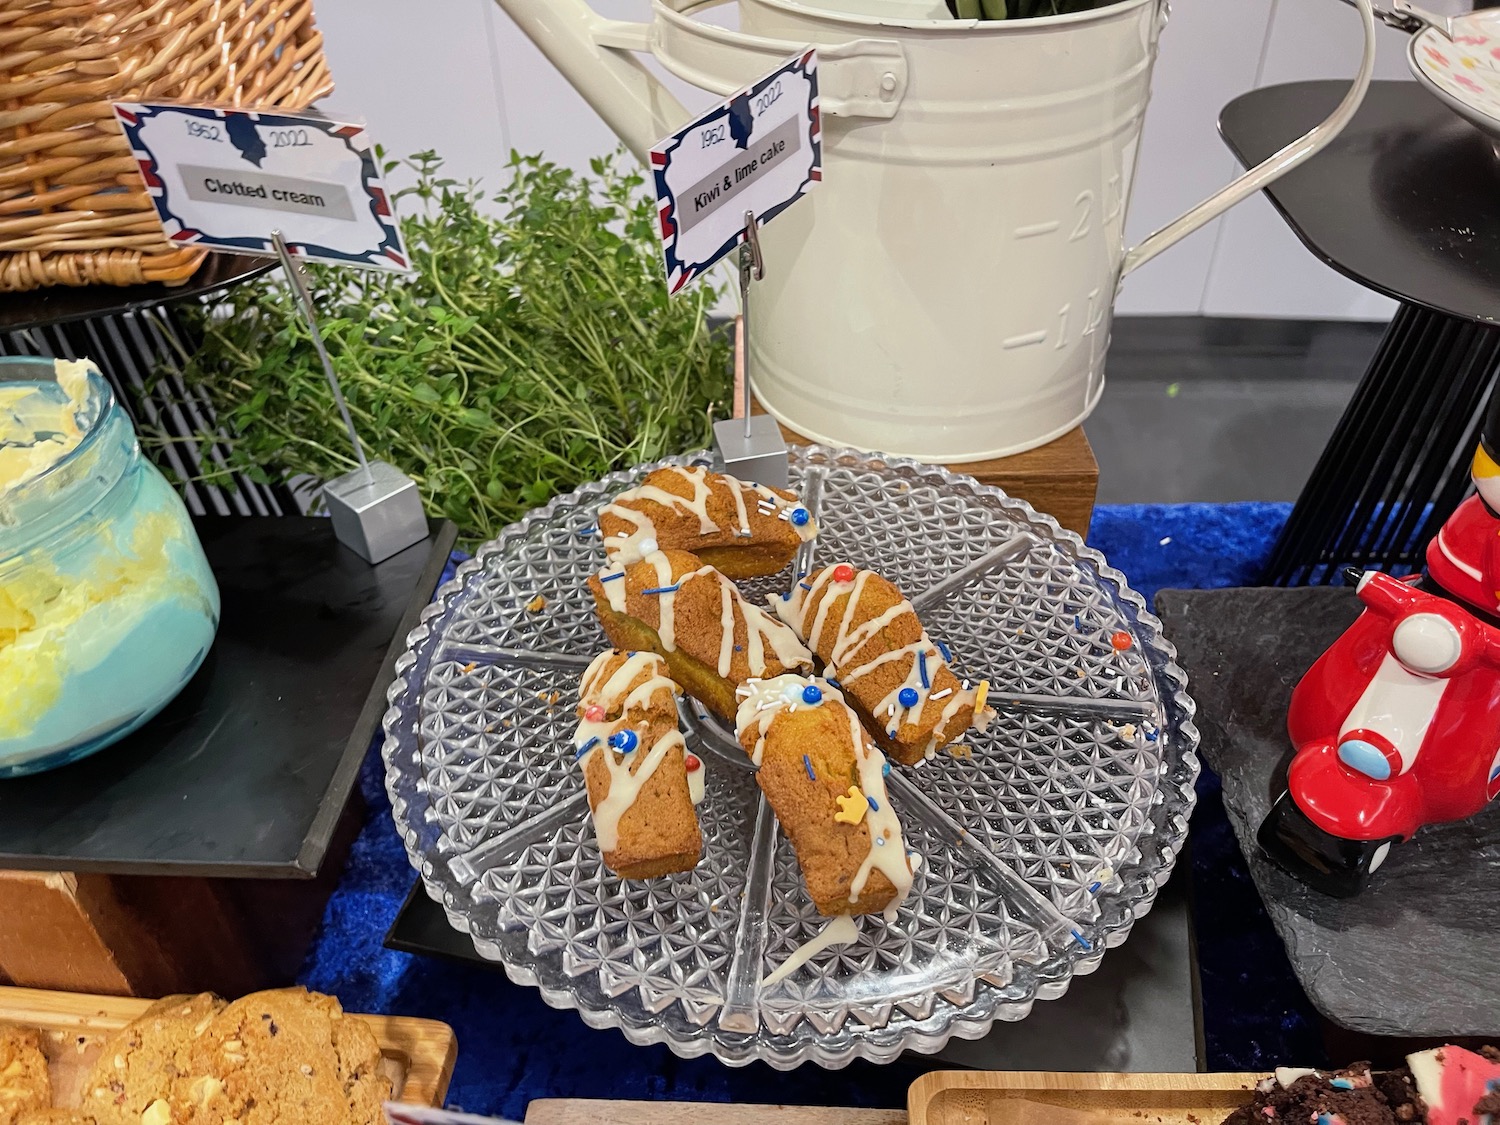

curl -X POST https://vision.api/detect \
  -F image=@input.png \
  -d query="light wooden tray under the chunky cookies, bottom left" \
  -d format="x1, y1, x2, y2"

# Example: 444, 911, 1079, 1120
0, 987, 459, 1106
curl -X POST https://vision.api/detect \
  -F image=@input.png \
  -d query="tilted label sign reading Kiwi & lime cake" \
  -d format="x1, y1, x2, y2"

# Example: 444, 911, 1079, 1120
651, 51, 824, 293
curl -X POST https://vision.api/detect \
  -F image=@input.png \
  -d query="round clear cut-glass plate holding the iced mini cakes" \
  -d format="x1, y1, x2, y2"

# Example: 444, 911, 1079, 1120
384, 446, 1199, 1070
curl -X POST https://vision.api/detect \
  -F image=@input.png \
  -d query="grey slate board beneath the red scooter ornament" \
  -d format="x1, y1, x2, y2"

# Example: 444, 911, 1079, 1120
1157, 588, 1500, 1038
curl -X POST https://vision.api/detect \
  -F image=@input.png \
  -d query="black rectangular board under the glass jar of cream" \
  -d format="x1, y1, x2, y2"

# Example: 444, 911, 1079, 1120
0, 516, 456, 878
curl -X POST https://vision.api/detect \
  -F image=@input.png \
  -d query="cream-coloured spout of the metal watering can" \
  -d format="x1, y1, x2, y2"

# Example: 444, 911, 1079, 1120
498, 0, 689, 161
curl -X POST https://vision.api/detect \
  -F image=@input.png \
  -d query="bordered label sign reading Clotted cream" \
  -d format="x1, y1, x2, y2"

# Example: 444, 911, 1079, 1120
114, 102, 407, 270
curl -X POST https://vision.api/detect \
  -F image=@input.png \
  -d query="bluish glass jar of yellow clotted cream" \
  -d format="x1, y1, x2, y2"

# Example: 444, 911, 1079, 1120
0, 359, 219, 777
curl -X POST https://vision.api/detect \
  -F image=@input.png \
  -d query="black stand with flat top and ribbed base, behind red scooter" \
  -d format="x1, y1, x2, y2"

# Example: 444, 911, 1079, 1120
1220, 81, 1500, 585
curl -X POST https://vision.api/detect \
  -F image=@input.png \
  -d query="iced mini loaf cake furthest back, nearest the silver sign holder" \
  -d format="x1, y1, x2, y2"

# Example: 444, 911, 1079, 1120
599, 465, 818, 579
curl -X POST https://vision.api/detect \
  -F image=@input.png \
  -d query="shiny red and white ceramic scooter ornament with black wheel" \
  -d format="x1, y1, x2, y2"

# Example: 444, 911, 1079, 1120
1259, 420, 1500, 897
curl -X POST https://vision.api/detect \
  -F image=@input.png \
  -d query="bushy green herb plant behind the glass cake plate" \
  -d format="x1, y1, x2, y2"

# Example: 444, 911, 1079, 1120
156, 152, 732, 540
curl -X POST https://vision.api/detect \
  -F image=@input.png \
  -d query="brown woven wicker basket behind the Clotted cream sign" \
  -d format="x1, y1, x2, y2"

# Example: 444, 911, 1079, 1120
0, 0, 333, 291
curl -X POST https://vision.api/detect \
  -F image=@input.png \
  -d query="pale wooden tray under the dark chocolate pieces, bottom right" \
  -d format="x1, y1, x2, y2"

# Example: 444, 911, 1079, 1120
906, 1071, 1265, 1125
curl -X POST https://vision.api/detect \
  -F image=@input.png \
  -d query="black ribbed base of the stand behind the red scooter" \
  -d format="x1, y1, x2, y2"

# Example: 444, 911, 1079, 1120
1262, 305, 1500, 587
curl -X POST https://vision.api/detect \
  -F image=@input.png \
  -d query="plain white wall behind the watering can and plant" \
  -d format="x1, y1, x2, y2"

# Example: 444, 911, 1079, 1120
317, 0, 1407, 320
